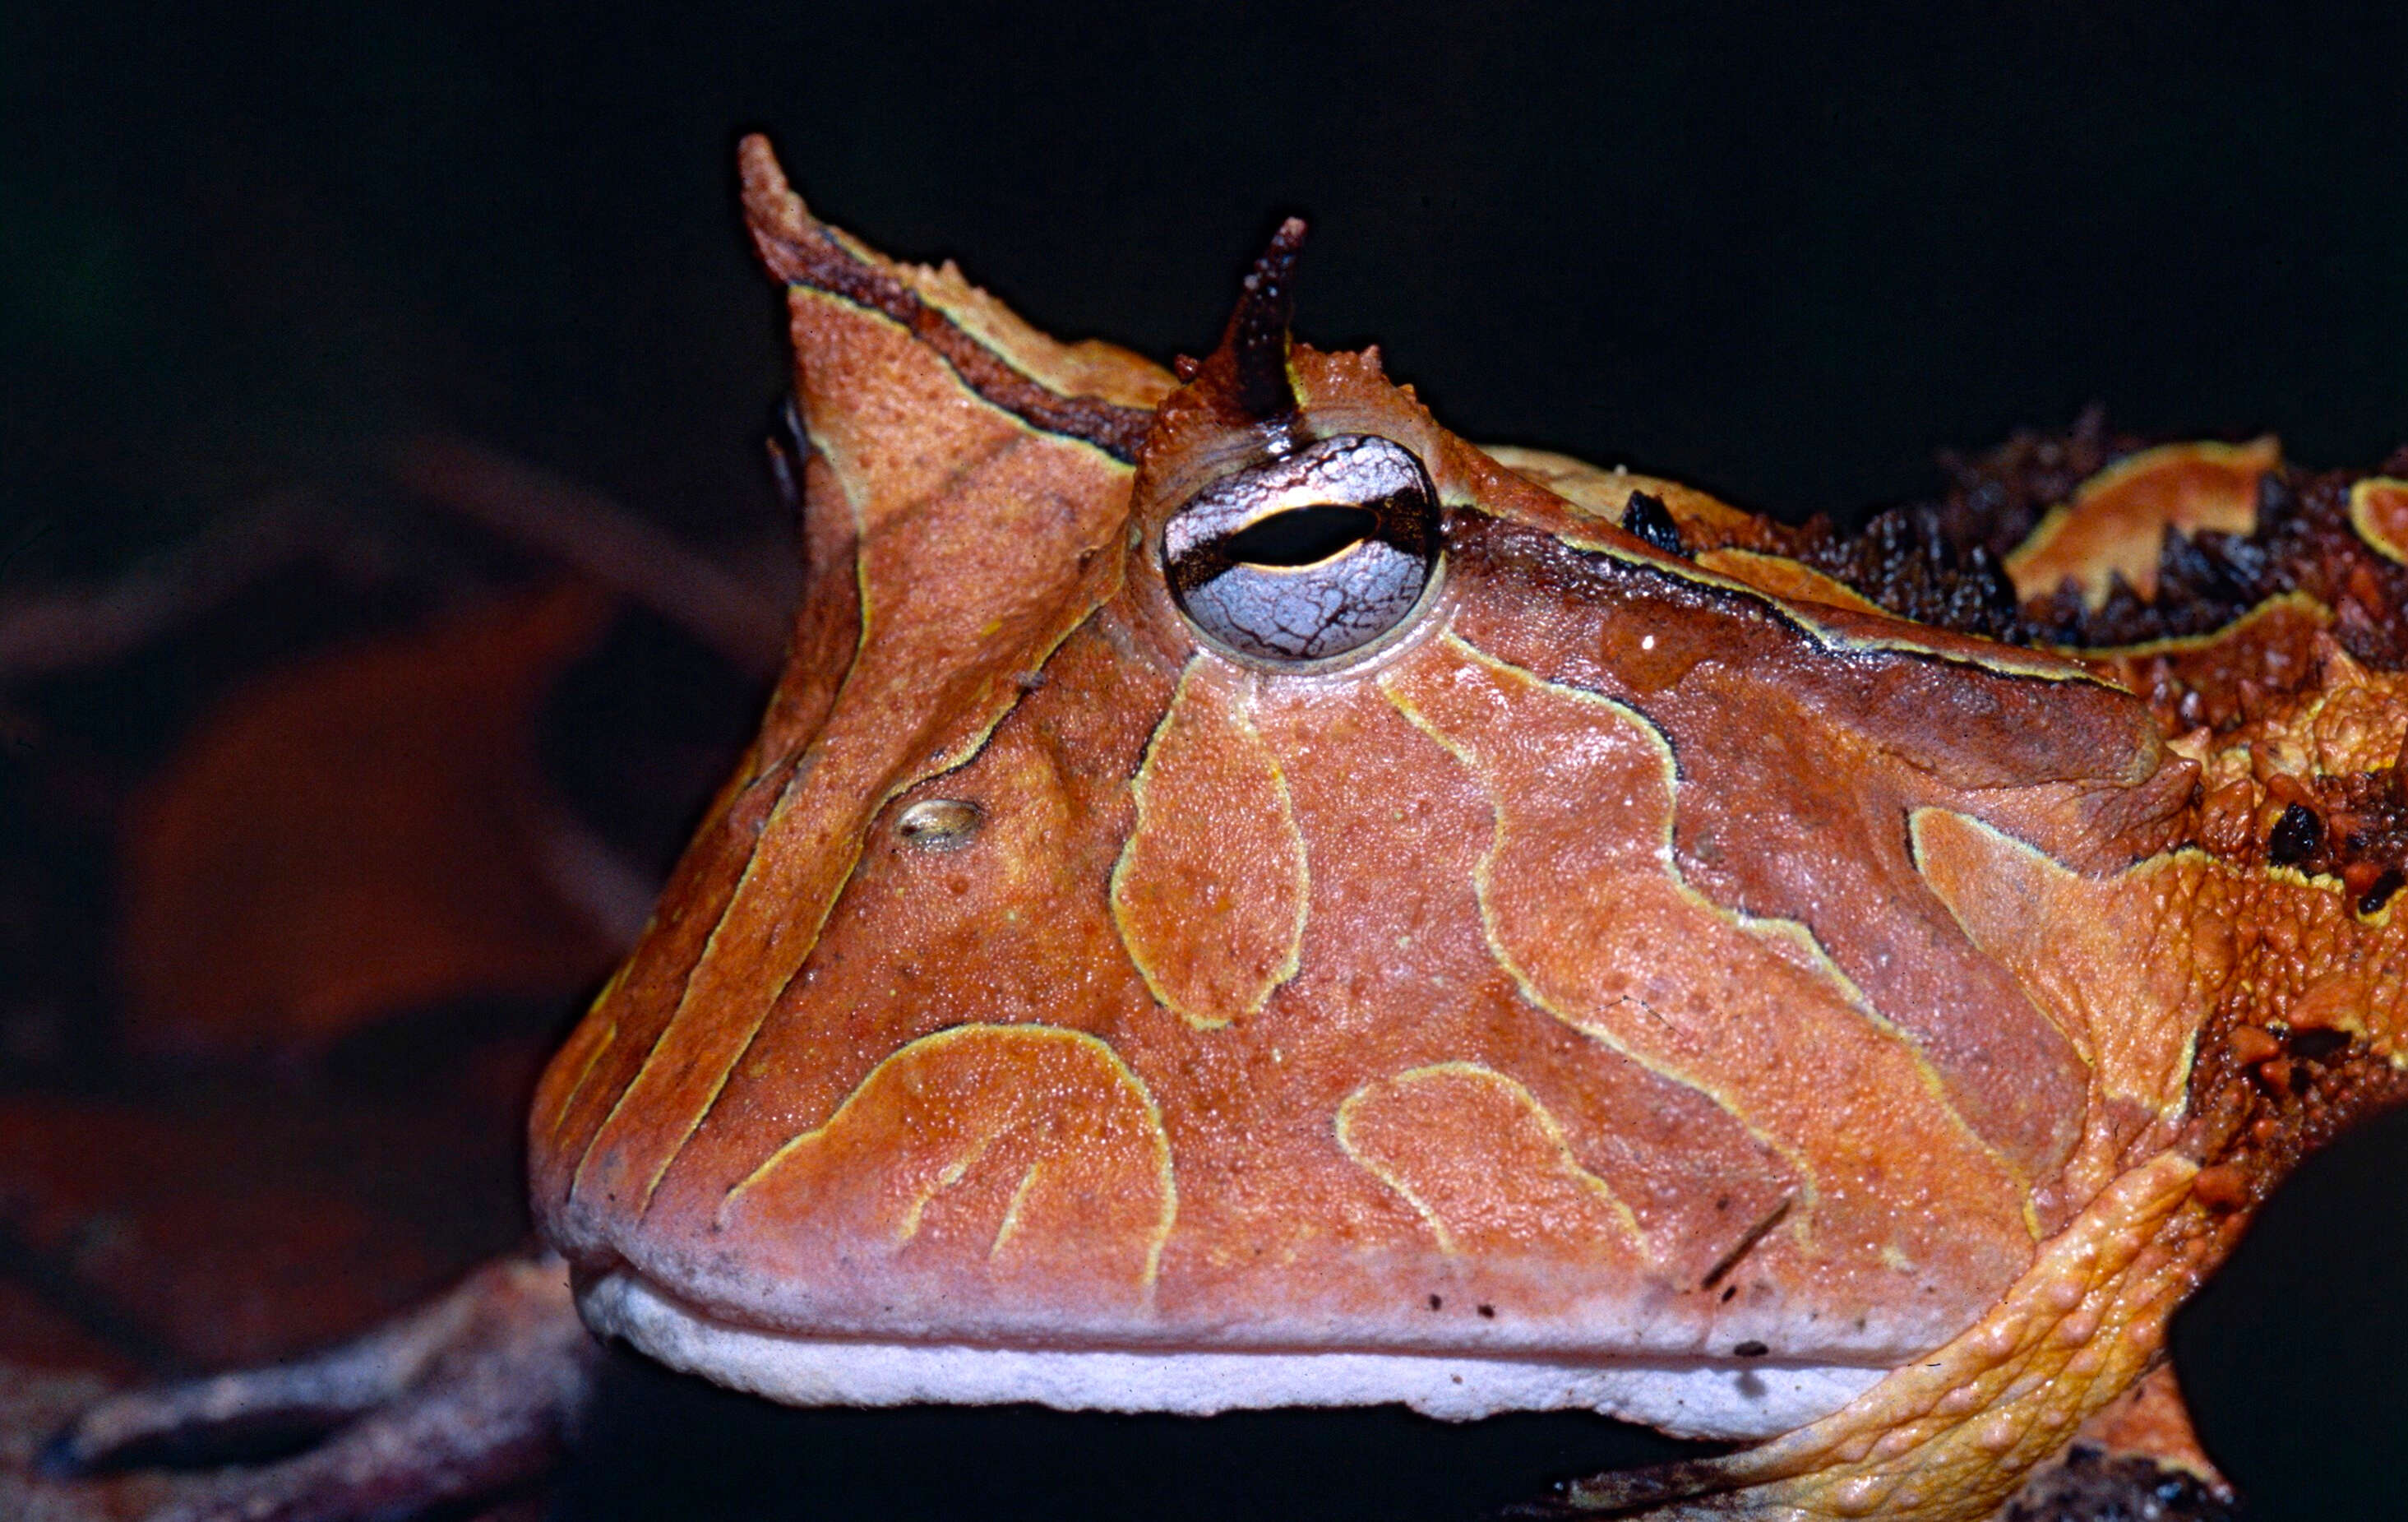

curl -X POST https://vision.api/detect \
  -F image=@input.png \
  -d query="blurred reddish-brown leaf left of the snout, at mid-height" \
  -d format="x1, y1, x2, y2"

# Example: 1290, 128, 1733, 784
120, 583, 626, 1055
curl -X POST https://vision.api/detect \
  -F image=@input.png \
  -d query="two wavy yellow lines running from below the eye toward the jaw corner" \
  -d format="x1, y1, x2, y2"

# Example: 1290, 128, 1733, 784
1380, 628, 2040, 1245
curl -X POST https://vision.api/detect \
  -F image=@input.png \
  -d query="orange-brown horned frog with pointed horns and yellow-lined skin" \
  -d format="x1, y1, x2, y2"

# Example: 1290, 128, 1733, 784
42, 140, 2408, 1522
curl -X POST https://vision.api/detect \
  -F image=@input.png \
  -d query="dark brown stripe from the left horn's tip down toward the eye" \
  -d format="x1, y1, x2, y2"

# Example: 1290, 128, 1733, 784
739, 137, 1153, 462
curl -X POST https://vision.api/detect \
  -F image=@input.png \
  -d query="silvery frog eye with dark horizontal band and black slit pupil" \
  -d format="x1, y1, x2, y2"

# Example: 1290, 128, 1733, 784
1163, 433, 1440, 662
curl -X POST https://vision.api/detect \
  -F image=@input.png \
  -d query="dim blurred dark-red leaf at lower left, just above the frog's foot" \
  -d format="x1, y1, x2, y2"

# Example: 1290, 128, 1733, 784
0, 1089, 523, 1372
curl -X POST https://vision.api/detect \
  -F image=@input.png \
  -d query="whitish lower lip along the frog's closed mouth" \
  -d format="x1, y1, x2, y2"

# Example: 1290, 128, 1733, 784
578, 1265, 1888, 1440
